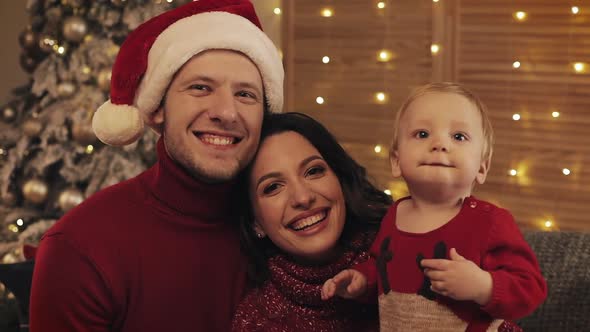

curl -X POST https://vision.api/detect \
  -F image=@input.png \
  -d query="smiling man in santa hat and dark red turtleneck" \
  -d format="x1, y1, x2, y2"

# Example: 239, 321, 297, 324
30, 0, 283, 332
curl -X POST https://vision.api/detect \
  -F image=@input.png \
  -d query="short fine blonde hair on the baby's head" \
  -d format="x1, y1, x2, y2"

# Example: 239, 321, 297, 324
390, 82, 494, 164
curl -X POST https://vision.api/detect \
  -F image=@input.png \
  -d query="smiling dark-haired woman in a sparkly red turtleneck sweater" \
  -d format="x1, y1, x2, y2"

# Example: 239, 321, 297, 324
233, 113, 391, 331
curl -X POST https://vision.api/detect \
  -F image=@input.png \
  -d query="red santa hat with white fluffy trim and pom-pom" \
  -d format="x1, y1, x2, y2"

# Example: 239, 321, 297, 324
92, 0, 284, 146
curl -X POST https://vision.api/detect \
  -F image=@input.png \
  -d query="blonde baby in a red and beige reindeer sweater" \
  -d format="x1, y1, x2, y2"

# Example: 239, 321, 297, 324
322, 83, 547, 331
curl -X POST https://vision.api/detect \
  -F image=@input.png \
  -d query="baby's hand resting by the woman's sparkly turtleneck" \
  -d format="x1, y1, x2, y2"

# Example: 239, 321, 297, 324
322, 269, 367, 301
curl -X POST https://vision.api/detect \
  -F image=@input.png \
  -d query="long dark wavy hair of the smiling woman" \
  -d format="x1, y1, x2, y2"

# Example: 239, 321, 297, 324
239, 112, 392, 284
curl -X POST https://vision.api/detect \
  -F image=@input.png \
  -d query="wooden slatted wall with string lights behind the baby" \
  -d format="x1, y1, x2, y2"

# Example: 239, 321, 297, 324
283, 0, 590, 230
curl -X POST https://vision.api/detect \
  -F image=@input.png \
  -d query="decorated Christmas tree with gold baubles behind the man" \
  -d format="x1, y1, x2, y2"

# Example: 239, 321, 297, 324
0, 0, 188, 272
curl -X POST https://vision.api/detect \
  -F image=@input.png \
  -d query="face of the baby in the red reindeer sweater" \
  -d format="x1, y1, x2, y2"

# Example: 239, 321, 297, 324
391, 92, 488, 195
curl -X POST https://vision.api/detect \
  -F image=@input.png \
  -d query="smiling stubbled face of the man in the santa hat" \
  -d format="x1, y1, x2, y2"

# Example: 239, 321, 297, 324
153, 50, 264, 183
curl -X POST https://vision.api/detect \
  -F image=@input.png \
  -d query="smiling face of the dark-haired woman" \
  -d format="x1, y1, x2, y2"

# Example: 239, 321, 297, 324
249, 131, 346, 262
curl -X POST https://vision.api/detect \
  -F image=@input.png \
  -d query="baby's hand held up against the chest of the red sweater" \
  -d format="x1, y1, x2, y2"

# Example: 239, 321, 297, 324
422, 248, 492, 306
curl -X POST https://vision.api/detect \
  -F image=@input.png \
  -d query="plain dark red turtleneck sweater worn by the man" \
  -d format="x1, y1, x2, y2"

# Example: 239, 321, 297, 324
30, 140, 246, 332
